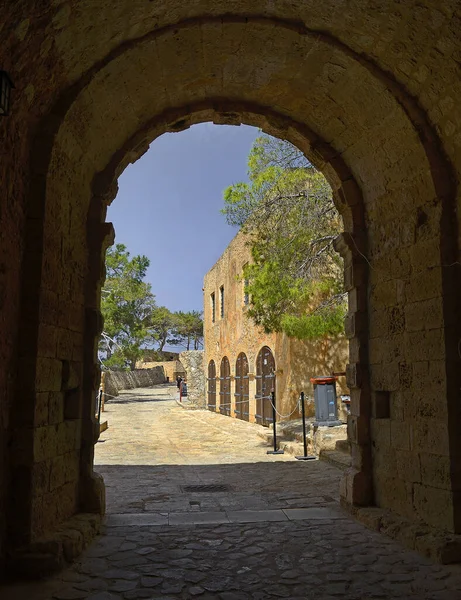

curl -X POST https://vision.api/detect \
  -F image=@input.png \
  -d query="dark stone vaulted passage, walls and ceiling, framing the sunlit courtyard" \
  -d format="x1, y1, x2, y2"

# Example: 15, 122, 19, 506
0, 0, 461, 572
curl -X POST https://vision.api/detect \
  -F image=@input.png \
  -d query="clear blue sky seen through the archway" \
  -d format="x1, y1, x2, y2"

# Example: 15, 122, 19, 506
107, 123, 258, 311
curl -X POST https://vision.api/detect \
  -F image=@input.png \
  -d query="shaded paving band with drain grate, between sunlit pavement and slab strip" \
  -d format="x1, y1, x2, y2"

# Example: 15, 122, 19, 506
95, 460, 341, 513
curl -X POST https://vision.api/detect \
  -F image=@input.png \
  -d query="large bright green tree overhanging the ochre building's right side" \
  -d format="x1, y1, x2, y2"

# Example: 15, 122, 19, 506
222, 135, 346, 339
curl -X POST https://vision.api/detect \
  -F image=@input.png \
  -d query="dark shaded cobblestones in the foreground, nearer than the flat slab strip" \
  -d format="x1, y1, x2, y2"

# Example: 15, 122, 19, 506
0, 518, 461, 600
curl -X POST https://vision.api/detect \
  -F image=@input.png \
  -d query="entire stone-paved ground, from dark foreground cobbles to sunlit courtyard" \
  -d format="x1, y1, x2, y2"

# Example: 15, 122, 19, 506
0, 384, 461, 600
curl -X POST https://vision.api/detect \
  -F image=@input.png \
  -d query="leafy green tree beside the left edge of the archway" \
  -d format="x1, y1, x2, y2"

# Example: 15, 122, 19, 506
99, 244, 155, 370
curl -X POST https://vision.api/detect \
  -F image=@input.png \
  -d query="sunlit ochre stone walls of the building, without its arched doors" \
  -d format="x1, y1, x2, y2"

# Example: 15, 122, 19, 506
203, 233, 348, 422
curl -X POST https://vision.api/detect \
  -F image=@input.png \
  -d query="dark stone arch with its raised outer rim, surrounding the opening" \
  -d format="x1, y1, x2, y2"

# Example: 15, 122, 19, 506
6, 9, 459, 572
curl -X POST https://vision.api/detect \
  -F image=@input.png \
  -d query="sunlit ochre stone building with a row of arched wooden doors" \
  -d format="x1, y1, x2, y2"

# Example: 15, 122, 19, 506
203, 233, 348, 425
